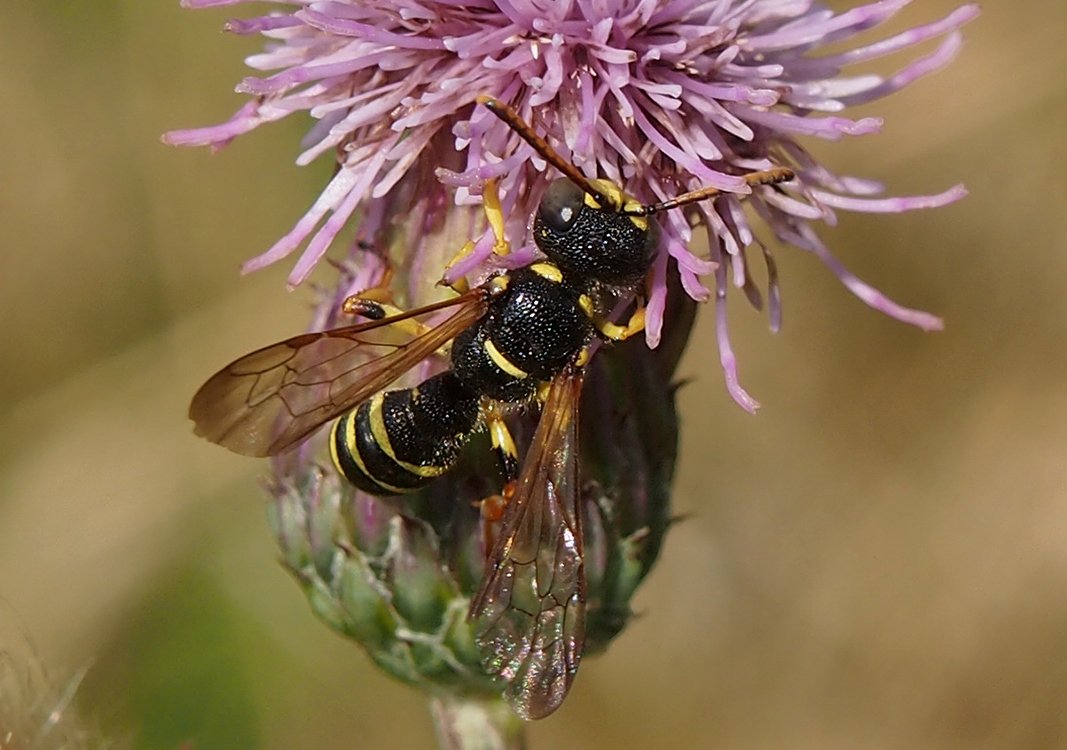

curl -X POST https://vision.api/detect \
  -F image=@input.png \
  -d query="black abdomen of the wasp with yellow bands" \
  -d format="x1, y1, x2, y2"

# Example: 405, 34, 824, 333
330, 370, 479, 495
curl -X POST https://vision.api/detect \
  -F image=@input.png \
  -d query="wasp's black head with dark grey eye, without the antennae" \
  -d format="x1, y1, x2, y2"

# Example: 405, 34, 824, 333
534, 179, 656, 286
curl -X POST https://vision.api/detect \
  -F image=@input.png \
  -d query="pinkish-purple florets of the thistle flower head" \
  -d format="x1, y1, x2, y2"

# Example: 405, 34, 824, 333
165, 0, 977, 410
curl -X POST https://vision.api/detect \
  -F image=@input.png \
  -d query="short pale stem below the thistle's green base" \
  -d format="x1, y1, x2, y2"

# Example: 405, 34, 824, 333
430, 696, 526, 750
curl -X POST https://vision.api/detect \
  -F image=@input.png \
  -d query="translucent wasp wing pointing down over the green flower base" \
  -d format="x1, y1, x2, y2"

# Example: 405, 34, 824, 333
469, 371, 586, 719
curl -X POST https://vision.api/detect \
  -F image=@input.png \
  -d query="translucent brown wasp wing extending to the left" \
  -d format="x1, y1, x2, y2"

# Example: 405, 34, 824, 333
189, 287, 489, 456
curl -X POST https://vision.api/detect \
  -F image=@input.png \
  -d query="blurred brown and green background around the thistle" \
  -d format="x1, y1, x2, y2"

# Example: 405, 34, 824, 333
0, 0, 1067, 749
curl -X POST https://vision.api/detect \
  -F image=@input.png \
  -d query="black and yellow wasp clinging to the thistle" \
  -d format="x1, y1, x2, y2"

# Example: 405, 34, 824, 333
189, 97, 793, 718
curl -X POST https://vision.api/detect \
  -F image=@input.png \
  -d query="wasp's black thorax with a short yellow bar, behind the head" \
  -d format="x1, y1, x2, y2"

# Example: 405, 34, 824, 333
452, 262, 593, 402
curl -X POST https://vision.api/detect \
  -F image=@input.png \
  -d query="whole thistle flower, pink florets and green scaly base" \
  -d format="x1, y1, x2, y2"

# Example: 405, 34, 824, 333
164, 0, 977, 733
